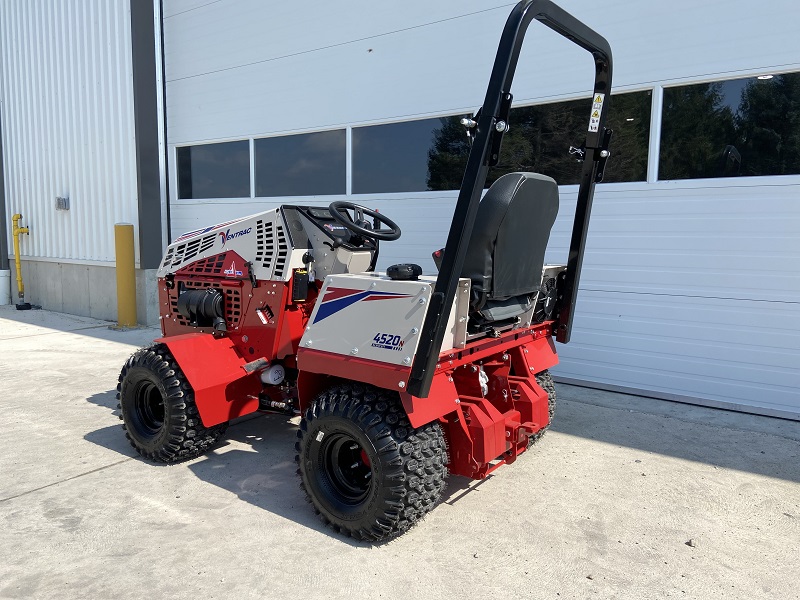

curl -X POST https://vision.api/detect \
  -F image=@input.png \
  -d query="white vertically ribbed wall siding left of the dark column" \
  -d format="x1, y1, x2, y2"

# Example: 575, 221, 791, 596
0, 0, 137, 262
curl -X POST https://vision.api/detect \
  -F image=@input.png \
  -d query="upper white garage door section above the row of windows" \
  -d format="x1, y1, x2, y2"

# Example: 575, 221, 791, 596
165, 0, 800, 144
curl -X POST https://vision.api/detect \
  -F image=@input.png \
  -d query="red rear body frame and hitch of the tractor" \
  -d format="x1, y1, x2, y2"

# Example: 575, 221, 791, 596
297, 321, 558, 479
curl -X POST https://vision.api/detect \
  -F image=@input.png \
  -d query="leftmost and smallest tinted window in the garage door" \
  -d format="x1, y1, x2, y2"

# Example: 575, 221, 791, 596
178, 140, 250, 199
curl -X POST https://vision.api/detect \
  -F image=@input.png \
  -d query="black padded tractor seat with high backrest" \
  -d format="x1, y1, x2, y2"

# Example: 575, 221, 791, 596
461, 173, 558, 320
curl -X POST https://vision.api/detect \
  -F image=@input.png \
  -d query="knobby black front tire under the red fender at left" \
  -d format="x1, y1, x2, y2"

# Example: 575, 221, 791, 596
117, 344, 228, 463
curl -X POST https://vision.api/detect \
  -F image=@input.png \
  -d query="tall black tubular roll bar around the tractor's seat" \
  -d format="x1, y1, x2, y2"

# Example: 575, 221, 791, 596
407, 0, 612, 398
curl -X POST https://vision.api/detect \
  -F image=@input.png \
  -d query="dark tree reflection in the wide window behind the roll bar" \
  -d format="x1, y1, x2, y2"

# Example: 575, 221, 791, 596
428, 91, 651, 190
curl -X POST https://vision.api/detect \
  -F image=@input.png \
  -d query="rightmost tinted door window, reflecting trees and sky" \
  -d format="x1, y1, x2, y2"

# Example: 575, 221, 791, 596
659, 73, 800, 179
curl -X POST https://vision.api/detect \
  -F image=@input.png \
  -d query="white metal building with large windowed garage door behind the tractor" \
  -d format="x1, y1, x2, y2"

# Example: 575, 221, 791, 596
0, 0, 800, 419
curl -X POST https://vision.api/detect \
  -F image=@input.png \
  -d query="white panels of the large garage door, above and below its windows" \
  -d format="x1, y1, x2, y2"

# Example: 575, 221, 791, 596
165, 0, 800, 418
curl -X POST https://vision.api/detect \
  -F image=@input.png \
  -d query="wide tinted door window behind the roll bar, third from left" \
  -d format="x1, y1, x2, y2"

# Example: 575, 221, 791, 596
353, 91, 651, 193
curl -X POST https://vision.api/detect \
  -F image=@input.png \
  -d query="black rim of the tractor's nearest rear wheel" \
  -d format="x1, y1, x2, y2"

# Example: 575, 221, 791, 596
320, 433, 372, 506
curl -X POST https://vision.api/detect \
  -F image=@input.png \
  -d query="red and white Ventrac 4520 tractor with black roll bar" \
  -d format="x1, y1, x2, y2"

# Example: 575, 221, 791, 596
117, 0, 612, 541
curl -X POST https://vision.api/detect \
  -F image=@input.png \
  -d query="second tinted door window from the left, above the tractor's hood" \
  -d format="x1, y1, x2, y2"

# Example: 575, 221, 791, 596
255, 129, 347, 196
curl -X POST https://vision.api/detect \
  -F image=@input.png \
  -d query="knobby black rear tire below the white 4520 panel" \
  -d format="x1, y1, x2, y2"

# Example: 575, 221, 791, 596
295, 383, 447, 542
